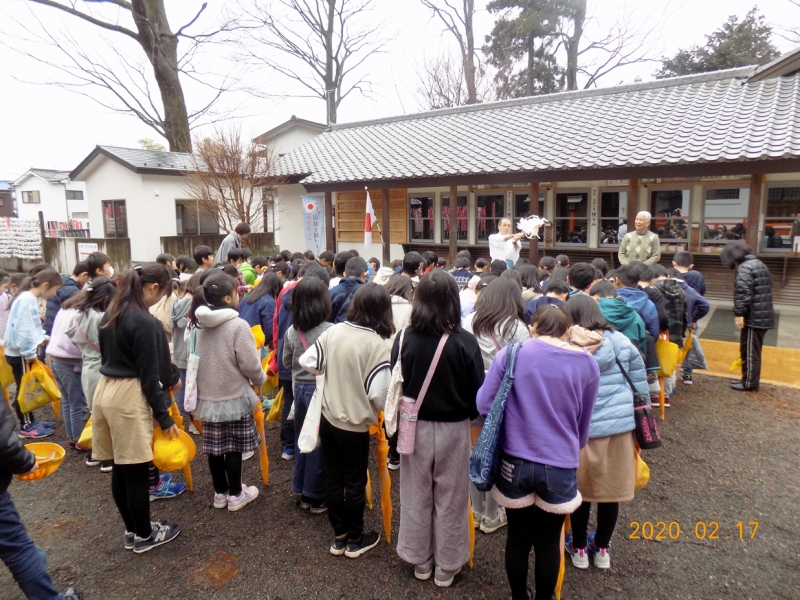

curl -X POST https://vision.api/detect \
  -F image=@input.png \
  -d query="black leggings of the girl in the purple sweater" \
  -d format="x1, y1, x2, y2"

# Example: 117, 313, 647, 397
506, 506, 566, 600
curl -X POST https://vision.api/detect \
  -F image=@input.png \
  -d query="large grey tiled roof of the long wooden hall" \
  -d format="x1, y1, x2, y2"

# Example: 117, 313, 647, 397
278, 67, 800, 185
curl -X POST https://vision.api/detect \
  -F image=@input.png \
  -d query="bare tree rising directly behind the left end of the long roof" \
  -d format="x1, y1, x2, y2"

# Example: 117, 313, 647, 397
241, 0, 387, 123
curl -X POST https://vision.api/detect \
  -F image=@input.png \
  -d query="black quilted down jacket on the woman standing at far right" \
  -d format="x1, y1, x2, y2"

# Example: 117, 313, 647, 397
733, 254, 775, 329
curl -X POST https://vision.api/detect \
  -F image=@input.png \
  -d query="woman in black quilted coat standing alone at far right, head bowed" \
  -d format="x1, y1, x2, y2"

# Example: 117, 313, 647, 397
720, 240, 775, 392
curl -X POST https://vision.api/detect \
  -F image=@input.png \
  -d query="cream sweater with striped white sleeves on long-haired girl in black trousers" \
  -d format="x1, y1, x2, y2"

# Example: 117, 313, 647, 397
300, 321, 391, 432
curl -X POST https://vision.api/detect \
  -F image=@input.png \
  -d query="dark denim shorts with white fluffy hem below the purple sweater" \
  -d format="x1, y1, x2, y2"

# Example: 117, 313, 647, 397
492, 452, 582, 514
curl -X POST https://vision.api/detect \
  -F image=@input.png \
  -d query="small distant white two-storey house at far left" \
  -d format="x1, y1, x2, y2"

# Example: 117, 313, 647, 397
13, 168, 89, 235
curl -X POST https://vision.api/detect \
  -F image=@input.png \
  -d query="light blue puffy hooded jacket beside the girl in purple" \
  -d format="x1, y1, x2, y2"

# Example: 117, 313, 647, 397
570, 326, 649, 438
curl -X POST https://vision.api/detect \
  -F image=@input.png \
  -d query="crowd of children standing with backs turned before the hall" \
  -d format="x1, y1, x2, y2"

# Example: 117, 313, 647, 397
0, 225, 752, 600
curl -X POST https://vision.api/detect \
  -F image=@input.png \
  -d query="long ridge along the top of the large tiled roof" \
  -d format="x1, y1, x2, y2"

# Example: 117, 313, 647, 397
328, 66, 756, 131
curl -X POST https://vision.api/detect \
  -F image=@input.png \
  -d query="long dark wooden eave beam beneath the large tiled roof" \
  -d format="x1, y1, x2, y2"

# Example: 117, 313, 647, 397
303, 158, 800, 192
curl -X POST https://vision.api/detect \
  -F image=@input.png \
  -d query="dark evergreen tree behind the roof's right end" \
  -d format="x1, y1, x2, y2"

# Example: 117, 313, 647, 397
655, 7, 780, 79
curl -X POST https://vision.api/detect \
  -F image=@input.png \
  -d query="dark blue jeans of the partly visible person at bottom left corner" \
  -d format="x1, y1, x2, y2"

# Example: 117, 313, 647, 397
0, 491, 63, 600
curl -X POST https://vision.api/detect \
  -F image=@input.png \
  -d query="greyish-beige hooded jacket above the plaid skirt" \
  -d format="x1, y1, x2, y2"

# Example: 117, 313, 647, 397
195, 306, 267, 423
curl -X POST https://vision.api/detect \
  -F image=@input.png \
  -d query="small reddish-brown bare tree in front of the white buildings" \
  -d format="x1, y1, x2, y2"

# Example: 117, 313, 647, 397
183, 127, 284, 232
